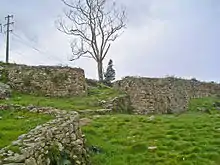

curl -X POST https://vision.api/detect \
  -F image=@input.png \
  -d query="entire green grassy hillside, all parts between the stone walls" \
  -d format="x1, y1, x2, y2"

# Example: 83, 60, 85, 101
0, 85, 220, 165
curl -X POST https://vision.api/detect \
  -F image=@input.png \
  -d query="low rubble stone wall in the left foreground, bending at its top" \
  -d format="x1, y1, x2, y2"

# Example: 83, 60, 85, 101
0, 105, 89, 165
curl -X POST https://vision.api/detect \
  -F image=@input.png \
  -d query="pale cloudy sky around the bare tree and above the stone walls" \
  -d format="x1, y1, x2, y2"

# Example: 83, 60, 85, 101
0, 0, 220, 81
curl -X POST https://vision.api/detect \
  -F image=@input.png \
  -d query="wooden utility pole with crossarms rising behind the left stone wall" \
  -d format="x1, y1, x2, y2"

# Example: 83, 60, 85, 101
4, 15, 14, 63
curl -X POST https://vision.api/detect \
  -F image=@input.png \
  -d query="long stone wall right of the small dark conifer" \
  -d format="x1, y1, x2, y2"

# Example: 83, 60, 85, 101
114, 77, 220, 114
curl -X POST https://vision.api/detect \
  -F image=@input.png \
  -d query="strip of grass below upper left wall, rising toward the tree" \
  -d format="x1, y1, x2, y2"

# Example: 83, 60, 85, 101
0, 86, 120, 110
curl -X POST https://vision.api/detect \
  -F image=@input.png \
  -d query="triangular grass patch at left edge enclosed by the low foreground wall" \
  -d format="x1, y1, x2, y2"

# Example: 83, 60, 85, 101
0, 110, 52, 149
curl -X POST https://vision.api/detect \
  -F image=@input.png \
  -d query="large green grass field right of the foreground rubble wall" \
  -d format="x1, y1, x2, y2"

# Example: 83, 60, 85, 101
83, 98, 220, 165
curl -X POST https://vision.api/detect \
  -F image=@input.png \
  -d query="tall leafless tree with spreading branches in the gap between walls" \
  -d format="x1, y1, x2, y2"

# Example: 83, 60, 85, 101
58, 0, 126, 81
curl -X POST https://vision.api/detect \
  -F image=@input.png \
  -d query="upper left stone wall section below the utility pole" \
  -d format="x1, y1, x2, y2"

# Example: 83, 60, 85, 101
0, 64, 87, 97
